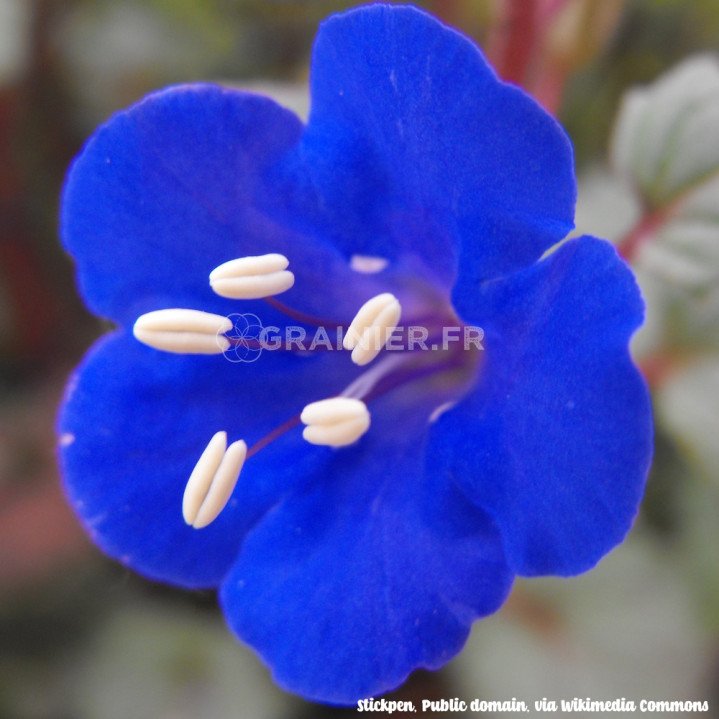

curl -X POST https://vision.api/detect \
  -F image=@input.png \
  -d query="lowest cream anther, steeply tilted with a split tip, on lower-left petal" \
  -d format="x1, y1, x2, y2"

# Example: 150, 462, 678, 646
182, 432, 247, 529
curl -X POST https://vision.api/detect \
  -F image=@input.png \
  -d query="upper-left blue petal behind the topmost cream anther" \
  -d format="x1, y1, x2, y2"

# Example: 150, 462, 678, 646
62, 85, 388, 330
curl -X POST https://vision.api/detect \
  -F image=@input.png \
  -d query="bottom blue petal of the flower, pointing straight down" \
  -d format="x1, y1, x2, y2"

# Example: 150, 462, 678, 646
221, 396, 511, 704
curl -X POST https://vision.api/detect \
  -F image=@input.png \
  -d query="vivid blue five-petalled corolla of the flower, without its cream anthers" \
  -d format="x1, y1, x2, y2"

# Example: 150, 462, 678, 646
60, 5, 652, 703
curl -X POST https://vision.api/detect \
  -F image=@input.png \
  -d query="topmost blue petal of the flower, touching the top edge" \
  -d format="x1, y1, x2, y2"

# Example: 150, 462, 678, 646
290, 5, 575, 284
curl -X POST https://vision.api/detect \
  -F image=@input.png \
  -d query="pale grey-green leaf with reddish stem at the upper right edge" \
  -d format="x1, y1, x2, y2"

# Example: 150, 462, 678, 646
611, 55, 719, 352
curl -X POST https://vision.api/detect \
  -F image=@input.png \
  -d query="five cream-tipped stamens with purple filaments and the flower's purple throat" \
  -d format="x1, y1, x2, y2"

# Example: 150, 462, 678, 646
134, 254, 483, 529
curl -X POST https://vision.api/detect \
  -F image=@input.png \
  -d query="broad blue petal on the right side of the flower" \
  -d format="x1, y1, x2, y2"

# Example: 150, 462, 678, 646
434, 238, 652, 575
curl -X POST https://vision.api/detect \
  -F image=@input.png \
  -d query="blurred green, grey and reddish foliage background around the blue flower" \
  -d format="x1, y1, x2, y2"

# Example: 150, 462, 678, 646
0, 0, 719, 719
